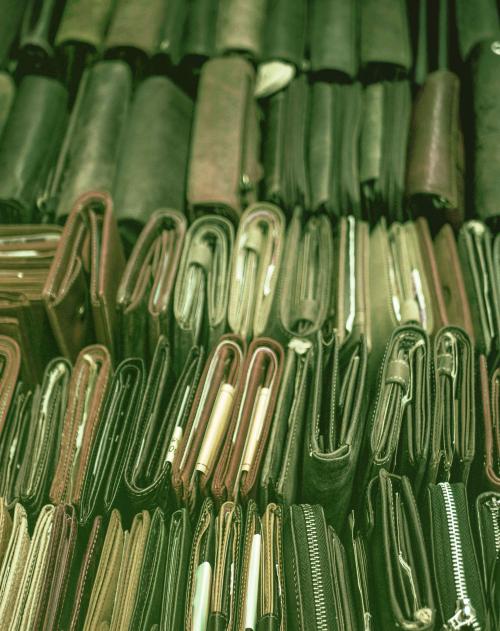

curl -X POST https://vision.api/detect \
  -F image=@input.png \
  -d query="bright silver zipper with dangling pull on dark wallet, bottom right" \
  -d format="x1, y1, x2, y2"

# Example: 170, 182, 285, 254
439, 482, 481, 631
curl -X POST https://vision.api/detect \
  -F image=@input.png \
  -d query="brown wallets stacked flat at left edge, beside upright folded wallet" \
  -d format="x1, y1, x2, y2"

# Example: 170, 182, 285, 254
0, 224, 61, 384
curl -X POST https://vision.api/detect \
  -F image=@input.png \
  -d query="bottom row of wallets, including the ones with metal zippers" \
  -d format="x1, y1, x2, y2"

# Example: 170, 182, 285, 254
0, 476, 500, 631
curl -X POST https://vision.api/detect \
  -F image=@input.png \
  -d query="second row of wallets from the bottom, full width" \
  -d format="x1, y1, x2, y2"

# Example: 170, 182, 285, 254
0, 314, 500, 530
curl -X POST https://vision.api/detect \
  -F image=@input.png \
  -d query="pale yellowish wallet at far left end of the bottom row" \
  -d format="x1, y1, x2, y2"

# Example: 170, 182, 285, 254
0, 503, 30, 629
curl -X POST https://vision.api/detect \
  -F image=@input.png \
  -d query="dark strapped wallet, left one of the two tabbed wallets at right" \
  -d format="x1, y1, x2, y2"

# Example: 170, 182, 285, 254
359, 324, 433, 496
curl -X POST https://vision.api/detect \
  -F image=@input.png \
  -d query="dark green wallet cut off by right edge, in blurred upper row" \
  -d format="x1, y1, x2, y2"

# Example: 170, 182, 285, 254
471, 37, 500, 229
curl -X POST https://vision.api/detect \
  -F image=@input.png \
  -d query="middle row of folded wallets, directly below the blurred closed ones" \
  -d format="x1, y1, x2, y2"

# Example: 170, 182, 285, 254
0, 193, 500, 383
